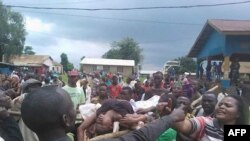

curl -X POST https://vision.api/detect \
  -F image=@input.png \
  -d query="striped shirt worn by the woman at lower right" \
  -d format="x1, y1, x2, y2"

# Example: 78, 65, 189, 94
190, 117, 224, 141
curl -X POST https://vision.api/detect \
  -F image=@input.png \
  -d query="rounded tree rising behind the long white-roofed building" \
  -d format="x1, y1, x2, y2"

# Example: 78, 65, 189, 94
102, 38, 143, 65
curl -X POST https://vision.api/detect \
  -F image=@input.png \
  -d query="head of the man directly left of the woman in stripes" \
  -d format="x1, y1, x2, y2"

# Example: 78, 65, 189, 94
201, 92, 217, 115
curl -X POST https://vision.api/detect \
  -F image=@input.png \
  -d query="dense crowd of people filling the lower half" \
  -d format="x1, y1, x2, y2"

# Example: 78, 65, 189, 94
0, 70, 249, 141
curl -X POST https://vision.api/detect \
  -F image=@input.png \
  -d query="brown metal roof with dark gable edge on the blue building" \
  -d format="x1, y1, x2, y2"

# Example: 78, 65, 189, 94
187, 19, 250, 57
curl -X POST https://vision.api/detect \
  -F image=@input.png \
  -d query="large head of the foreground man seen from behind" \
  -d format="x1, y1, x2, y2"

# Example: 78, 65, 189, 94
21, 86, 76, 138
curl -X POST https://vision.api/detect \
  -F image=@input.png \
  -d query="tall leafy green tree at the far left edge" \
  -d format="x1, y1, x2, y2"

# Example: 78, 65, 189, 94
0, 1, 26, 61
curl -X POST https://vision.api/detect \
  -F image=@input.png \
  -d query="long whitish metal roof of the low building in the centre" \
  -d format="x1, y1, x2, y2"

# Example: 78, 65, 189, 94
81, 58, 135, 66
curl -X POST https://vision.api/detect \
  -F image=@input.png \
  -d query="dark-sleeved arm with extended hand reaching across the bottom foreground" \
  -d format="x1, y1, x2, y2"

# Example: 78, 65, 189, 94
97, 106, 185, 141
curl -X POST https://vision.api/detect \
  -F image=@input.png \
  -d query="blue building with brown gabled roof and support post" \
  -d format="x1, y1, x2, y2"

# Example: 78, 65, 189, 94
187, 19, 250, 87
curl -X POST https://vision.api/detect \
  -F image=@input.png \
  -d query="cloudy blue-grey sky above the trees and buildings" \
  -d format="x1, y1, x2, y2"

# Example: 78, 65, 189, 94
2, 0, 250, 70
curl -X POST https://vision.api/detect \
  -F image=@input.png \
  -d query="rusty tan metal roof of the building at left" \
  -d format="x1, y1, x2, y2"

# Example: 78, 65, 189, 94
10, 55, 53, 66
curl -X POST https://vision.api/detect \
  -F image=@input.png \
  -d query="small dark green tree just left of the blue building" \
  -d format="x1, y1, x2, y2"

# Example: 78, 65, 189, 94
175, 57, 196, 73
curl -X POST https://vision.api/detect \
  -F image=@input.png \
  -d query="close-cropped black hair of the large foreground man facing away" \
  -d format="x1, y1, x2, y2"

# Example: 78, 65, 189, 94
21, 86, 69, 133
